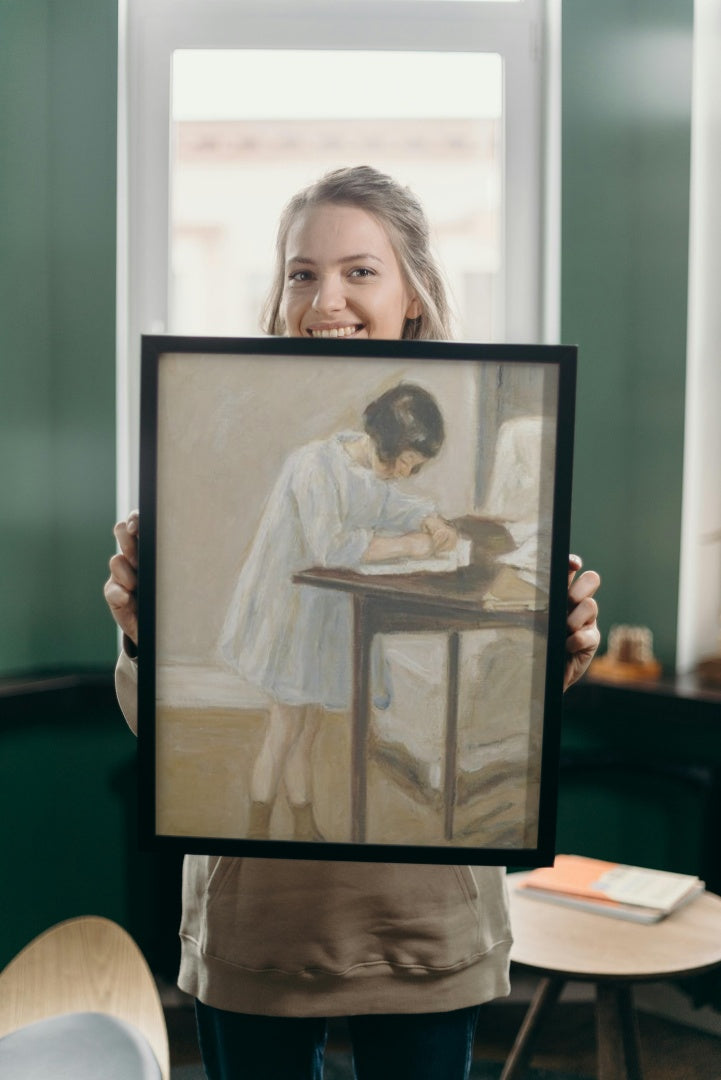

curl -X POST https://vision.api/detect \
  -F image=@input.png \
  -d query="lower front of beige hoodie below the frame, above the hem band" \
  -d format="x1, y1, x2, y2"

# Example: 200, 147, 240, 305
183, 856, 508, 974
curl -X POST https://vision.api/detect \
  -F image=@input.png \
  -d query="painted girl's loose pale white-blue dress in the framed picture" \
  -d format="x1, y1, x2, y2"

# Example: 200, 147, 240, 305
220, 432, 435, 710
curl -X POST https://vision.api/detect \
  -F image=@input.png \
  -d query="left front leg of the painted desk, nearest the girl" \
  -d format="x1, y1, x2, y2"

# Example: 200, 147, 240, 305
351, 596, 373, 843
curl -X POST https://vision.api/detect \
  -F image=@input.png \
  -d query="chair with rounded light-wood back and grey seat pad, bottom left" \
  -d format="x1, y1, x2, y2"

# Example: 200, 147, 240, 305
0, 916, 171, 1080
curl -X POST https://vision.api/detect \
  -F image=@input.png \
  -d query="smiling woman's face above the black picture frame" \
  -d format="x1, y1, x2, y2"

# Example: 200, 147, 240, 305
281, 203, 421, 339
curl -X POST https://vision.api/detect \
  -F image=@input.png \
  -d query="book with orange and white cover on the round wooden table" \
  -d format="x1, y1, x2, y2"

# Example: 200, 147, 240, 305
517, 855, 705, 922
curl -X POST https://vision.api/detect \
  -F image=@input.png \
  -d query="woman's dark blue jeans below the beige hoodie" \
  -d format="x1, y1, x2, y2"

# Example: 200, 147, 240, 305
195, 1001, 479, 1080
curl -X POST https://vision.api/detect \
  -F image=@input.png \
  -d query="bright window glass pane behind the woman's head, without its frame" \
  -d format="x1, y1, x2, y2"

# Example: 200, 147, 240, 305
168, 49, 503, 340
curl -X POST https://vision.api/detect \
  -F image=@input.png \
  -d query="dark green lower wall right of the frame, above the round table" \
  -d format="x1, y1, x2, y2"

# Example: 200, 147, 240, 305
557, 683, 721, 892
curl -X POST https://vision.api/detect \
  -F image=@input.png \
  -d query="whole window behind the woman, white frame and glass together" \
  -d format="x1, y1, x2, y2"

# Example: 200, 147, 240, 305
118, 0, 556, 513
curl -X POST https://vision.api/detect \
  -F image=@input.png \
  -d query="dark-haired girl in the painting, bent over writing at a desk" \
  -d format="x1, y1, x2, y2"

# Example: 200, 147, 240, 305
216, 383, 457, 840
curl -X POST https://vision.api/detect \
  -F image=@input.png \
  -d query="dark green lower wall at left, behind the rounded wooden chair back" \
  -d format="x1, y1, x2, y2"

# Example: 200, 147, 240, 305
0, 675, 180, 980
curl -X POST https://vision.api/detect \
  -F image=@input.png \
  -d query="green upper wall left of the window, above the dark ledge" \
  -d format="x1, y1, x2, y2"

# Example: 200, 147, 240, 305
0, 0, 118, 675
